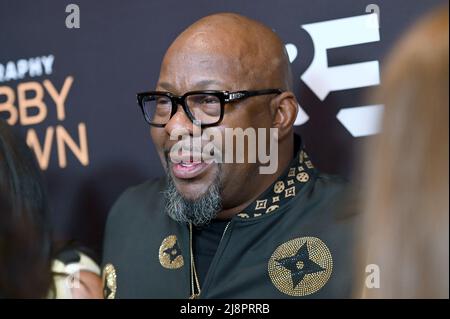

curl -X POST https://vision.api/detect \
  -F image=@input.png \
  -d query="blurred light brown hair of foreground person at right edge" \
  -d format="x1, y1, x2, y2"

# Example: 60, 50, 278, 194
359, 7, 449, 298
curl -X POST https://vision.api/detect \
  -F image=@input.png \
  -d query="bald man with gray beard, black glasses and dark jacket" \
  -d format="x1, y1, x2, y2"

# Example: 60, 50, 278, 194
103, 14, 355, 298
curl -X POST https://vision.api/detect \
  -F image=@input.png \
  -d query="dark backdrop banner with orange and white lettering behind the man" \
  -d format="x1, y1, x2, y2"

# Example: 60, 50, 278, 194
0, 0, 447, 252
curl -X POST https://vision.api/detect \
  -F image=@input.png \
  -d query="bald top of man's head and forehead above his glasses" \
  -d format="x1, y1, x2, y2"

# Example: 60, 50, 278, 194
158, 14, 284, 90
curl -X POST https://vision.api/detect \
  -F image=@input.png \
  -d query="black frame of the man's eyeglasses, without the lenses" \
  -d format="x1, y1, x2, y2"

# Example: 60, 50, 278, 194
136, 89, 284, 128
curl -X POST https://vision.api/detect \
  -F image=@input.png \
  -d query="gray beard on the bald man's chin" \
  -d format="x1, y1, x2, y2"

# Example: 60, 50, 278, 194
163, 165, 222, 226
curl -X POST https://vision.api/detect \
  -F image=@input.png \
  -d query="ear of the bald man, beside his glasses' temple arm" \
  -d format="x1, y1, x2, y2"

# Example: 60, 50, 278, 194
271, 91, 298, 140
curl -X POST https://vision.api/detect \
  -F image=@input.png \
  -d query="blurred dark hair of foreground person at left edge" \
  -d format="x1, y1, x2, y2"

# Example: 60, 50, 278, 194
0, 120, 52, 298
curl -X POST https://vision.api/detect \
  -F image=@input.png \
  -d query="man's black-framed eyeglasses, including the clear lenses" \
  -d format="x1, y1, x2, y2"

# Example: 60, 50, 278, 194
137, 89, 283, 127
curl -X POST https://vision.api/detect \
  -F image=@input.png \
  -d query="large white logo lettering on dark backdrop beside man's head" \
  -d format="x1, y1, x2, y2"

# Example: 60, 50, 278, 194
286, 12, 383, 137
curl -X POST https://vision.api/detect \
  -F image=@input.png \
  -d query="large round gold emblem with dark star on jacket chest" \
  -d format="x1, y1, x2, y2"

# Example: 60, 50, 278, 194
268, 237, 333, 297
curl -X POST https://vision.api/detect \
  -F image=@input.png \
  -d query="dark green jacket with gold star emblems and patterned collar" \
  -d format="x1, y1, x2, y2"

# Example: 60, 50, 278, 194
103, 151, 357, 298
